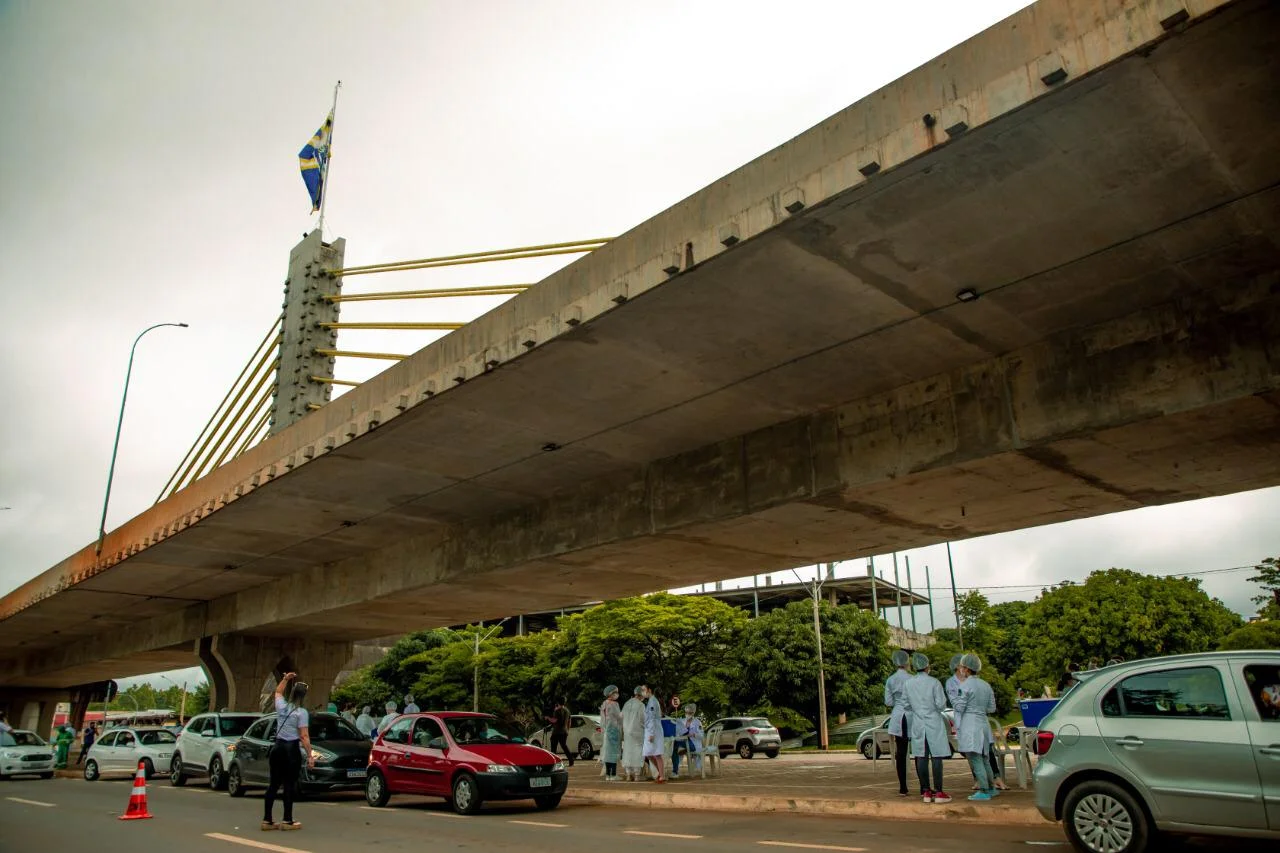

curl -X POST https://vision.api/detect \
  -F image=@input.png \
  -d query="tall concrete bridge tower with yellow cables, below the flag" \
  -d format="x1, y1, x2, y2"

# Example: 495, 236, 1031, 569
270, 231, 347, 435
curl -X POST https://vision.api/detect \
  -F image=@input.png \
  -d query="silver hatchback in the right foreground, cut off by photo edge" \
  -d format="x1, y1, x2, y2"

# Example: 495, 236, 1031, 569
1034, 651, 1280, 853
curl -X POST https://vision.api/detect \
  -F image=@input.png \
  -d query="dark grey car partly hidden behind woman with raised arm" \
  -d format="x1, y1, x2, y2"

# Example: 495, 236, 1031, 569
227, 712, 374, 797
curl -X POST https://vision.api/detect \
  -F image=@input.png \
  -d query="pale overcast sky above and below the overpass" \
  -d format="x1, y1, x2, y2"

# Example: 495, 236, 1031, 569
0, 0, 1280, 686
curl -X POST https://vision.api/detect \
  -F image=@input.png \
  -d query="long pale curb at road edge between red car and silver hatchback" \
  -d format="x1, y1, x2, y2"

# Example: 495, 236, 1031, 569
564, 788, 1051, 826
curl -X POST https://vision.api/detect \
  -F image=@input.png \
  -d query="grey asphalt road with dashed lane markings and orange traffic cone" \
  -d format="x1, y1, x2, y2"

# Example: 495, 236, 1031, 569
0, 779, 1262, 853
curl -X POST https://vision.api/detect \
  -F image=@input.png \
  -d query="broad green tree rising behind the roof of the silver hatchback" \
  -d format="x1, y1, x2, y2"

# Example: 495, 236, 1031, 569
1018, 569, 1240, 694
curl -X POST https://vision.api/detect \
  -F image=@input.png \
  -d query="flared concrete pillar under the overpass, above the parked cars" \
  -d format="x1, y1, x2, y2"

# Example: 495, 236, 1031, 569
197, 634, 352, 711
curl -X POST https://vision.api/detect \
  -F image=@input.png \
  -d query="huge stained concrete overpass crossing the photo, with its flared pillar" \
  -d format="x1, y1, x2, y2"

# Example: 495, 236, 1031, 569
0, 0, 1280, 706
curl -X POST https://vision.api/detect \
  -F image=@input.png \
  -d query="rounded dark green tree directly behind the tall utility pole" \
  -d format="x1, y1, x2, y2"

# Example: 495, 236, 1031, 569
732, 601, 891, 720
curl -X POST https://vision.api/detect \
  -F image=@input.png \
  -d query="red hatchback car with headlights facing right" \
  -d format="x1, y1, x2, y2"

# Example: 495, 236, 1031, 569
365, 711, 568, 815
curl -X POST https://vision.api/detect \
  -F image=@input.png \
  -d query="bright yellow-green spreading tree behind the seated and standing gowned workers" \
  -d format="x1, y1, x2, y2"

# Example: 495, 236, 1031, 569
563, 593, 748, 703
